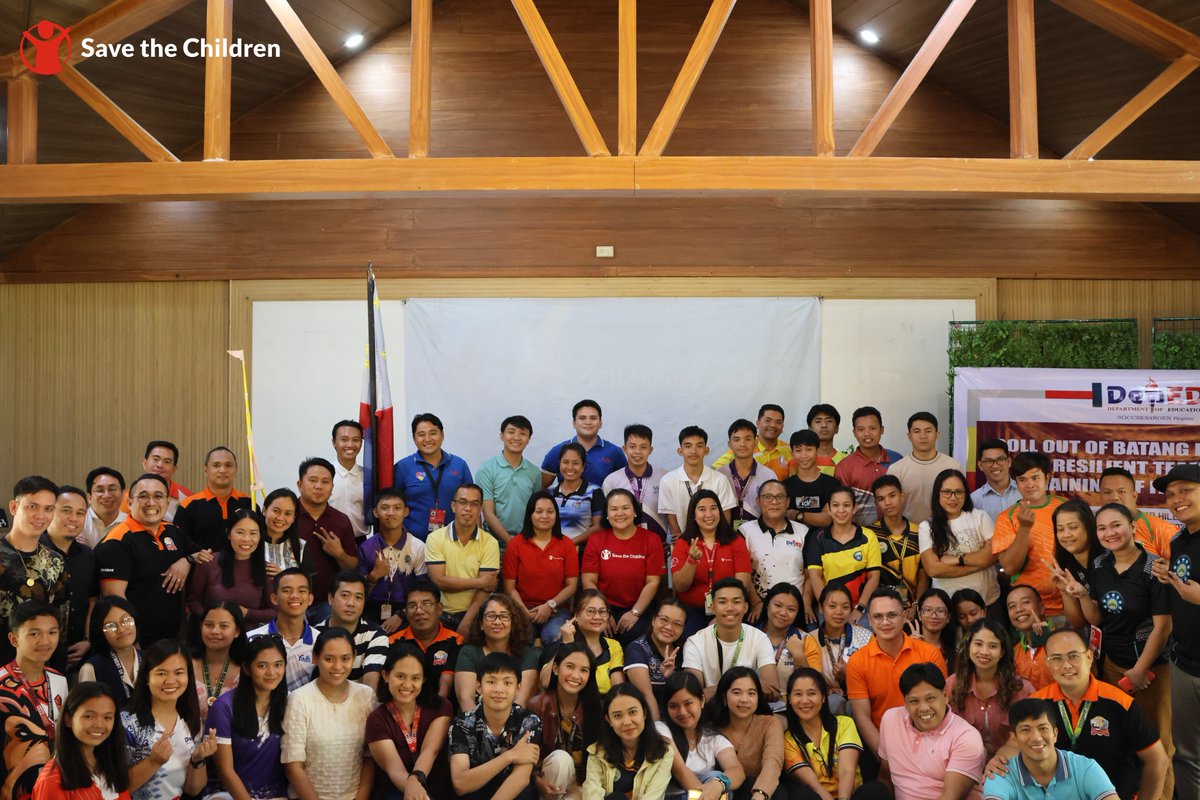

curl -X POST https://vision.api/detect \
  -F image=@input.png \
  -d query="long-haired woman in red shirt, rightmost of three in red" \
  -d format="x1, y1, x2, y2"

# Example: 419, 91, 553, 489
671, 489, 752, 636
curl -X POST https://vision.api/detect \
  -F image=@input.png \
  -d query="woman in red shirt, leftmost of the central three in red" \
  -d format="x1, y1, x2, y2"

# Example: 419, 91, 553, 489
504, 491, 580, 645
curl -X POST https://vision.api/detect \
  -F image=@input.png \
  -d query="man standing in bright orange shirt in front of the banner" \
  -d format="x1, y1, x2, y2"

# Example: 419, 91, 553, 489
991, 452, 1063, 616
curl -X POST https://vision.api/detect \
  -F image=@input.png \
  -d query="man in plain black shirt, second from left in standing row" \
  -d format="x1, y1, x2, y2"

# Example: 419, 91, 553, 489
38, 486, 100, 669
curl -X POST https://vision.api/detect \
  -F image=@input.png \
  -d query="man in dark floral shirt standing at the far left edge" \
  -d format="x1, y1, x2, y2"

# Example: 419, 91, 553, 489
0, 475, 70, 664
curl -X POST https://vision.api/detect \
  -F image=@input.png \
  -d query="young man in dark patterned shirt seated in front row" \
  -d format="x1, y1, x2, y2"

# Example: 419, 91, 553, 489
450, 652, 541, 800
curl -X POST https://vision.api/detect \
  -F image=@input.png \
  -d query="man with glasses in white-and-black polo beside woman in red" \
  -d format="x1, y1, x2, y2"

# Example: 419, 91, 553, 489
739, 479, 815, 621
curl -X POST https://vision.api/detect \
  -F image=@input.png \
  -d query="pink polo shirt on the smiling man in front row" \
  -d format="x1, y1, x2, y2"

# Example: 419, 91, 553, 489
880, 708, 986, 800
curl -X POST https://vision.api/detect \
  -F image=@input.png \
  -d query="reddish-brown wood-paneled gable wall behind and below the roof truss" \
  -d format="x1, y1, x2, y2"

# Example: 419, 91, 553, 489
0, 0, 1200, 282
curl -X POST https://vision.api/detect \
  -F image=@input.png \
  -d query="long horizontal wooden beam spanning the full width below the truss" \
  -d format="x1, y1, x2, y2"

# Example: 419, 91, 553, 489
0, 156, 1200, 203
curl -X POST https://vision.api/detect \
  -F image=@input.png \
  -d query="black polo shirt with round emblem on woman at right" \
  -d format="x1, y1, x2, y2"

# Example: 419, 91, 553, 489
1088, 546, 1171, 669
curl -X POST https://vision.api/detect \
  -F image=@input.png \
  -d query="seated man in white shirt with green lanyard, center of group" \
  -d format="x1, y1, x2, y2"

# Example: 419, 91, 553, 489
683, 578, 780, 700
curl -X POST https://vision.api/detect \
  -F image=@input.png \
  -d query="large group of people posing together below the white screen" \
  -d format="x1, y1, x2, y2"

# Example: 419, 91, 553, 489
0, 401, 1200, 800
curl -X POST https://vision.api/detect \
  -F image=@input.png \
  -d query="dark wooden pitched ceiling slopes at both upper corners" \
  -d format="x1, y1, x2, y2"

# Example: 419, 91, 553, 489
0, 0, 1200, 260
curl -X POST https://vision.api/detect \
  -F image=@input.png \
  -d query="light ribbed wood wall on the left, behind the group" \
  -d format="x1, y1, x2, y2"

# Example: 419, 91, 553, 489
0, 281, 232, 501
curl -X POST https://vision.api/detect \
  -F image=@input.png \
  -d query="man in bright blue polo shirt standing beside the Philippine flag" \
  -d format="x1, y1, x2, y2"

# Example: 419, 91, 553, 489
391, 414, 472, 542
